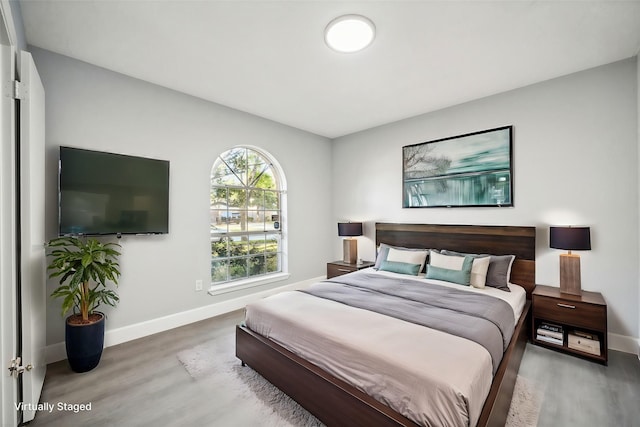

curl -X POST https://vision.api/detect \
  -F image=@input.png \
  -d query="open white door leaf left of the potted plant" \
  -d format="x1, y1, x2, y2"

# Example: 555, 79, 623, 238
18, 52, 47, 422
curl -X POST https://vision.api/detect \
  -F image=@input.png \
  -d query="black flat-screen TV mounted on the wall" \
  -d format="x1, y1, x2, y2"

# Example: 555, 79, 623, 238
58, 147, 169, 235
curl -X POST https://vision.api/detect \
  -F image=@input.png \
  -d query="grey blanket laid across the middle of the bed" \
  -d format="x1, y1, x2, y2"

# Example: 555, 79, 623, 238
301, 273, 515, 374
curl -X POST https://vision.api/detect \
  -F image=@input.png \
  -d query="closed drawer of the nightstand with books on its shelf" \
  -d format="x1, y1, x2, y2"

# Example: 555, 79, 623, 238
534, 295, 607, 331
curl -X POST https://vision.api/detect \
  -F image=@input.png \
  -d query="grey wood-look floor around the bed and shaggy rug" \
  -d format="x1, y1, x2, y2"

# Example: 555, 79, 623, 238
29, 311, 640, 427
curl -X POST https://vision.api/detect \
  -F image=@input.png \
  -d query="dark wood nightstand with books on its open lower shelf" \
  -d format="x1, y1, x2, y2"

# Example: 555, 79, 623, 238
531, 285, 608, 365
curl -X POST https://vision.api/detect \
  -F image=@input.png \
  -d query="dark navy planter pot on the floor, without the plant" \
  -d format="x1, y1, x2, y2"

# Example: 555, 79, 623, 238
65, 312, 104, 372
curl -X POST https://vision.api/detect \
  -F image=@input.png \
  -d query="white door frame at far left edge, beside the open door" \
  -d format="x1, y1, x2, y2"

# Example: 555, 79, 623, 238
0, 38, 18, 426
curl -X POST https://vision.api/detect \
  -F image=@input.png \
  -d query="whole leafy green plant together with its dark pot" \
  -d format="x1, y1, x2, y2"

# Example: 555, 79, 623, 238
47, 236, 120, 372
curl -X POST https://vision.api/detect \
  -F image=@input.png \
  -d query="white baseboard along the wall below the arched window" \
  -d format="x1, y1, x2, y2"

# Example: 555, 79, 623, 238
45, 276, 325, 364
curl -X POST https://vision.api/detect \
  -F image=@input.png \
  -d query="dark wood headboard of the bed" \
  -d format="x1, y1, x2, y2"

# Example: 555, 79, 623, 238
376, 222, 536, 299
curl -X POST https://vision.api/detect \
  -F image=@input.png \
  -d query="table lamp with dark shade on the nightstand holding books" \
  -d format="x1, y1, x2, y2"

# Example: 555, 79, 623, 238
549, 227, 591, 295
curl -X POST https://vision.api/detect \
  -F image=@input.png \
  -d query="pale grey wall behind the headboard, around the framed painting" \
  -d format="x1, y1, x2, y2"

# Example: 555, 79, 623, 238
333, 58, 639, 352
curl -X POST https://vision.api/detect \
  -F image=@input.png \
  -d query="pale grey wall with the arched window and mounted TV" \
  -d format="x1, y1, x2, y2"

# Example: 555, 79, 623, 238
31, 48, 335, 345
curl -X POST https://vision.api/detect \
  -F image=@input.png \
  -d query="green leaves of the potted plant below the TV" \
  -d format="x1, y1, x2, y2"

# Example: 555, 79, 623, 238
47, 237, 120, 321
